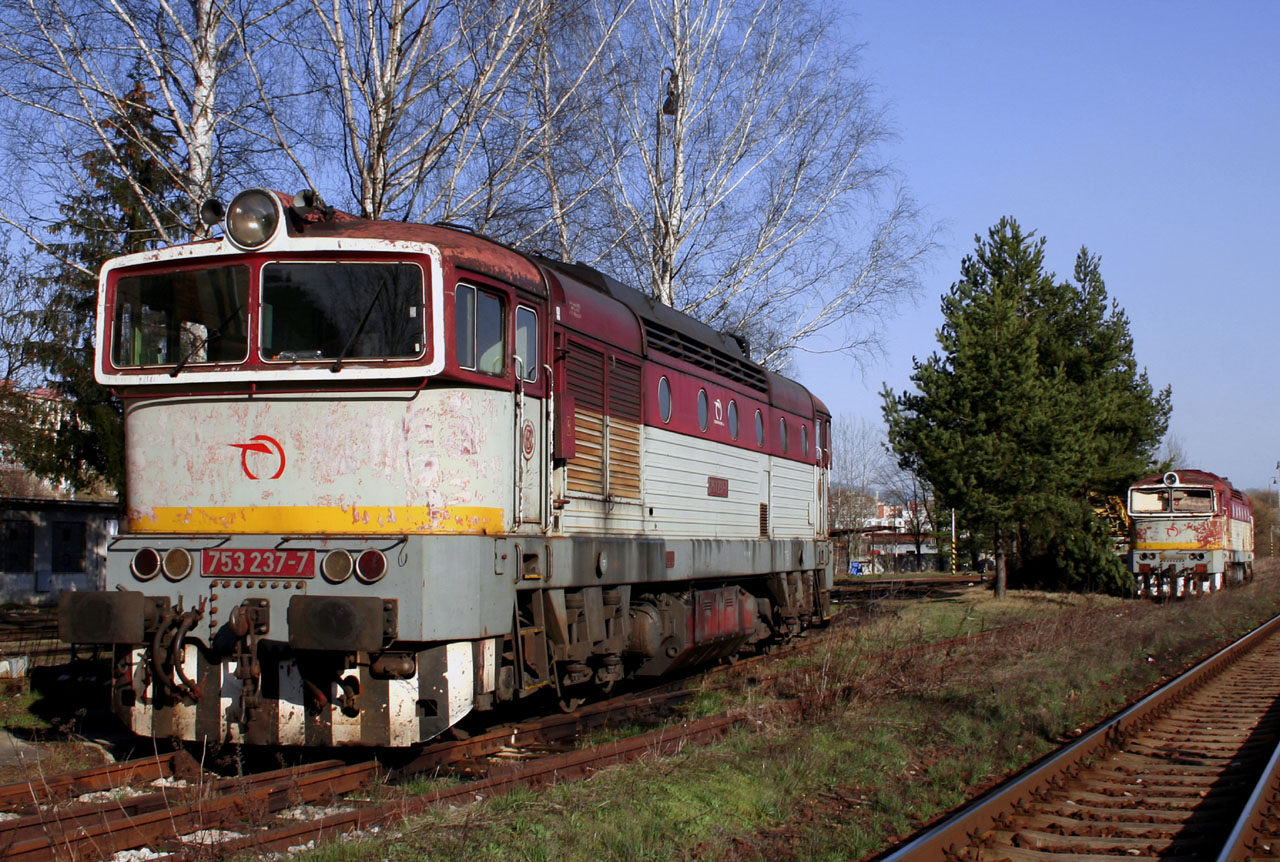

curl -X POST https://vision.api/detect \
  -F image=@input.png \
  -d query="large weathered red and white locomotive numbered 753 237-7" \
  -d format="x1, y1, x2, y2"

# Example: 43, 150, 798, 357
59, 190, 832, 745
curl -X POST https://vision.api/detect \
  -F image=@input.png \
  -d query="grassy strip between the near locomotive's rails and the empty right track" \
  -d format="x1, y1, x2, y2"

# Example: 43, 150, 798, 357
285, 579, 1280, 862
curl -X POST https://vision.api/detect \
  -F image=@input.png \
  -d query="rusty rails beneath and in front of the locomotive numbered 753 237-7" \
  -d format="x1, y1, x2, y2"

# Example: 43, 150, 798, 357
0, 594, 1080, 862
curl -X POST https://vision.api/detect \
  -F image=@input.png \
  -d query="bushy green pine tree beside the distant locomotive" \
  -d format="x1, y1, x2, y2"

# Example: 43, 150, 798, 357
883, 218, 1169, 596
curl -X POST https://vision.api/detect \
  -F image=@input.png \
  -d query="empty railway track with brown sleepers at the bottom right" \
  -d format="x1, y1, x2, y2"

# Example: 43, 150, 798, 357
881, 617, 1280, 862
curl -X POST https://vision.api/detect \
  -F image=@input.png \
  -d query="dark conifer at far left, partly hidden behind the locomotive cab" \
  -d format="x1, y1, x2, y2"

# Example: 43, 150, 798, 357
14, 76, 180, 489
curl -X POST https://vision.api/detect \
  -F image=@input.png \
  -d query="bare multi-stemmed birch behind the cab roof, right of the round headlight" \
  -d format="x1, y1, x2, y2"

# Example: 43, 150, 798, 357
298, 0, 554, 222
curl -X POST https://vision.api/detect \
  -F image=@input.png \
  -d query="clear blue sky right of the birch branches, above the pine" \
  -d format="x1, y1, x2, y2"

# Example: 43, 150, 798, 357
792, 0, 1280, 488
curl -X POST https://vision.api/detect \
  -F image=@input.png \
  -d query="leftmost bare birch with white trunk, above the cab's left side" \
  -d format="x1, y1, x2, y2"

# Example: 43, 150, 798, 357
0, 0, 301, 256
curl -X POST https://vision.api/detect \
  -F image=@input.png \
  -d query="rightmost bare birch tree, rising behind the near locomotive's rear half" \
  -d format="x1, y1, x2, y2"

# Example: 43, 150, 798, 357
555, 0, 932, 366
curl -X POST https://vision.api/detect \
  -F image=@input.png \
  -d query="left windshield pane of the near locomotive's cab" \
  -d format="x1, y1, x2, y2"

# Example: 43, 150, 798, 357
111, 266, 248, 368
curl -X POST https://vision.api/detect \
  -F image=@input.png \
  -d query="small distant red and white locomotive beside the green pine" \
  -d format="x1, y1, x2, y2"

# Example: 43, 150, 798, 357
1128, 470, 1253, 596
